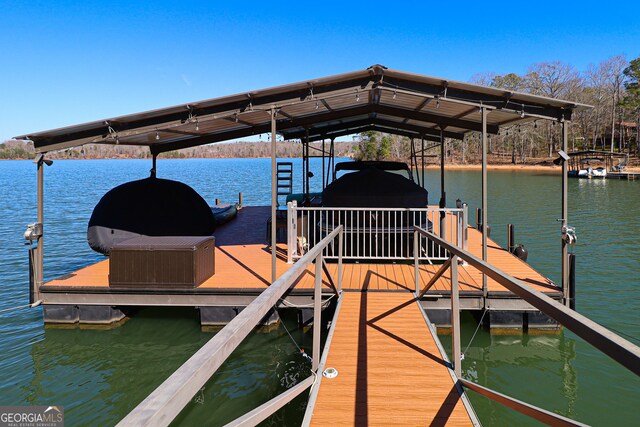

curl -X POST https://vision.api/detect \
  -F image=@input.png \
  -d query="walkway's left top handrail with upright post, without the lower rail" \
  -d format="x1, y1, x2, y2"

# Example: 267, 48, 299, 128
117, 226, 342, 427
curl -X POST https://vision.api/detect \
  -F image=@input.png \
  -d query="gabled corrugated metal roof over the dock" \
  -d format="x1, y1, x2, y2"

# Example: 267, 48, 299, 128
16, 65, 589, 153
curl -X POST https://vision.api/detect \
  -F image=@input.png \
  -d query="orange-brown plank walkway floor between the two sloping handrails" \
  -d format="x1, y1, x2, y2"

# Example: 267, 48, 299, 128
312, 292, 472, 426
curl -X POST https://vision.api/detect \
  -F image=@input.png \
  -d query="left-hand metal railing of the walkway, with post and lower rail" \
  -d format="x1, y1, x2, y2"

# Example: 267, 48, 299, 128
118, 226, 343, 427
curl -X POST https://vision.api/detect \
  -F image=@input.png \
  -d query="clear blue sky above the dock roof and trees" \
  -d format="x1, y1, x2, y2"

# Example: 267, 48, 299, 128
0, 0, 640, 141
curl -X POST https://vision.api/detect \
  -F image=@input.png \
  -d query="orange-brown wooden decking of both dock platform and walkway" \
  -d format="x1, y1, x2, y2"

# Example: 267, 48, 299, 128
41, 207, 559, 425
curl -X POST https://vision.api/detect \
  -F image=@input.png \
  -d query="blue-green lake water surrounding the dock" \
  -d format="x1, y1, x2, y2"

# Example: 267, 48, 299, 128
0, 159, 640, 425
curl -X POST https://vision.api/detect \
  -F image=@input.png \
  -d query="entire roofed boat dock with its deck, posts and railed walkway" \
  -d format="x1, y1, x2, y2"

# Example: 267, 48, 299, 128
20, 65, 640, 426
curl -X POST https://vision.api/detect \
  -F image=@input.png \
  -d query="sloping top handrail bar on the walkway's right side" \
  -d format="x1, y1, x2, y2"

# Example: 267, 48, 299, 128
415, 227, 640, 376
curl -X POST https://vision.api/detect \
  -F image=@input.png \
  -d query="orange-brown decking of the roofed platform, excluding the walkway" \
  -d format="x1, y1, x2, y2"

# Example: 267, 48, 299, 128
43, 207, 558, 293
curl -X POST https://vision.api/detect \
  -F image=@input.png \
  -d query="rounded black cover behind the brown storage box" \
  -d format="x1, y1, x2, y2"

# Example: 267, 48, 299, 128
87, 178, 215, 255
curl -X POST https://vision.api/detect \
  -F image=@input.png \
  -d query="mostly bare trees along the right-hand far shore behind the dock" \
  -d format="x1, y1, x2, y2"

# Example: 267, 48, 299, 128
356, 55, 640, 163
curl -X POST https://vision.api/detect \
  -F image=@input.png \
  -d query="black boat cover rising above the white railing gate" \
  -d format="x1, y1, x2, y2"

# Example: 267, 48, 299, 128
322, 168, 428, 208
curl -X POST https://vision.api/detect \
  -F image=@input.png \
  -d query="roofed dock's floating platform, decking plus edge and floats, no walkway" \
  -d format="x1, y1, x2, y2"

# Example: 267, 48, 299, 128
40, 207, 562, 330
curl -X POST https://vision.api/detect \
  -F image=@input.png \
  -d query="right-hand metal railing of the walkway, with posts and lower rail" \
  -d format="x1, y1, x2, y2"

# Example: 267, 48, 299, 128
414, 227, 640, 425
